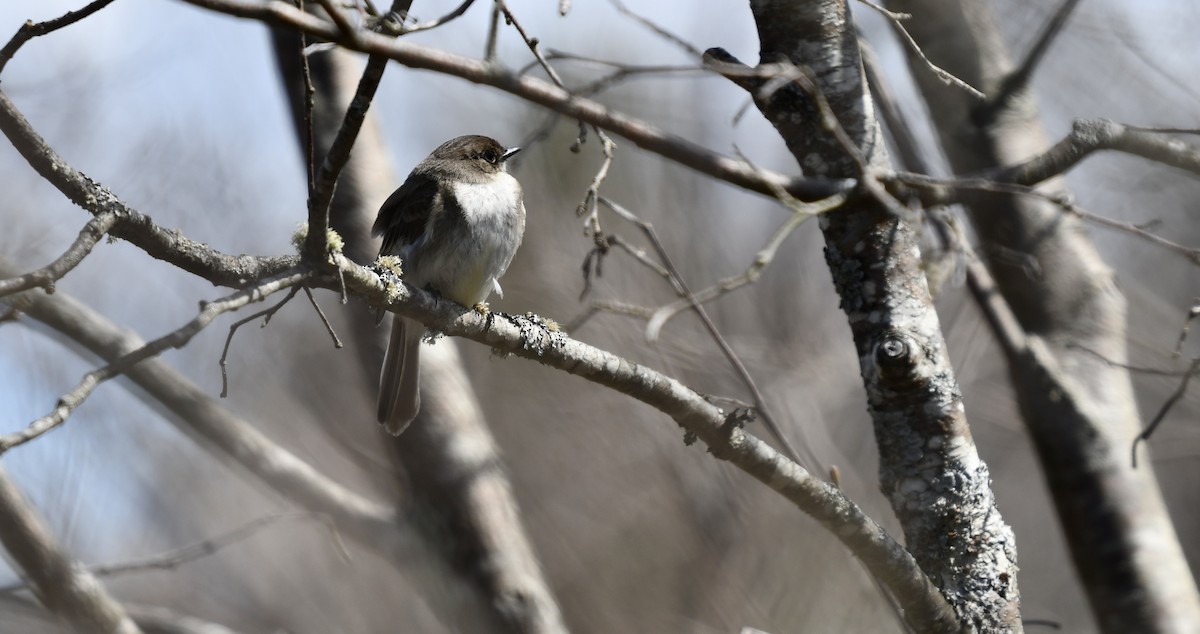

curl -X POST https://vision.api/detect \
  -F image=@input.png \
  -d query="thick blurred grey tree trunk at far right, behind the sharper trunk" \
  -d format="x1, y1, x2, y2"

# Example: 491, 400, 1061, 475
889, 0, 1200, 633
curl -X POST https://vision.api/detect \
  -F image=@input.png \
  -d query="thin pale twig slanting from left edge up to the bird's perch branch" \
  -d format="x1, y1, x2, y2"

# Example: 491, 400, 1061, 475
0, 268, 310, 455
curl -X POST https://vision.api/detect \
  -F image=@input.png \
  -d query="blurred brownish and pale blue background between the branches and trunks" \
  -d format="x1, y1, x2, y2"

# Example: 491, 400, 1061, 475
0, 0, 1200, 633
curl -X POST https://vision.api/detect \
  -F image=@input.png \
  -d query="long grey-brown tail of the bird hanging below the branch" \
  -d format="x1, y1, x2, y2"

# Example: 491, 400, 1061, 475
379, 315, 425, 436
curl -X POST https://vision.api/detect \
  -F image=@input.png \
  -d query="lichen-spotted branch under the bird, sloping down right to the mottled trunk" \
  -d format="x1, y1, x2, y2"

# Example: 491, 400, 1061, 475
328, 256, 956, 632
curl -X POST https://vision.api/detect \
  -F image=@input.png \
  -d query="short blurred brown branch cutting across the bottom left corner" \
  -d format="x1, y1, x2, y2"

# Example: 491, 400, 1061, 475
0, 467, 142, 634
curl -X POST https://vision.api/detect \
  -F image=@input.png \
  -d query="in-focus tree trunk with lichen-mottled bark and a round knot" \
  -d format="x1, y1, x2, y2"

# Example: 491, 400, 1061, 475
709, 0, 1021, 632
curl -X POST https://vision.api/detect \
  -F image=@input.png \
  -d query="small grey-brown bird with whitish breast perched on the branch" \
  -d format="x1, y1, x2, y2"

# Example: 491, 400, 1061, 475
371, 134, 524, 436
